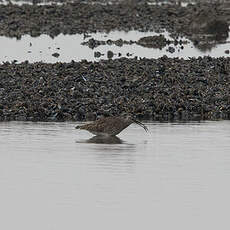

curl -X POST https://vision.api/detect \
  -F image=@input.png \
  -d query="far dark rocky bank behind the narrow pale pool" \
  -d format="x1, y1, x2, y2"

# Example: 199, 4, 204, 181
0, 0, 230, 43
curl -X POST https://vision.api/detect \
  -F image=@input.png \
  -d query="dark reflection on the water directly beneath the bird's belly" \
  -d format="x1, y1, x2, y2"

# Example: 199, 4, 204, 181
76, 136, 124, 144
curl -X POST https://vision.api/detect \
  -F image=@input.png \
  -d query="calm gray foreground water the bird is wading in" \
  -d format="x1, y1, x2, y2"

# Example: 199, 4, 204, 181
0, 121, 230, 230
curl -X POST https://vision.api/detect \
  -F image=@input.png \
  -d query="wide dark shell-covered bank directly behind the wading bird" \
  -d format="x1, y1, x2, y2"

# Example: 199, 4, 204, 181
0, 56, 230, 121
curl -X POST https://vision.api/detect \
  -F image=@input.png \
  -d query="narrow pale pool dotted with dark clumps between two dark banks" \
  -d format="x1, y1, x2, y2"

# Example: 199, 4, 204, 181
0, 31, 230, 63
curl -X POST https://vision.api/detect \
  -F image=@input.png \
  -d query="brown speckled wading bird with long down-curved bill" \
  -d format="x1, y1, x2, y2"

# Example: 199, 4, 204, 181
76, 116, 148, 136
